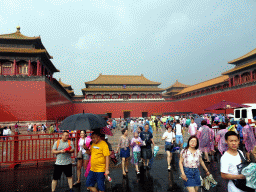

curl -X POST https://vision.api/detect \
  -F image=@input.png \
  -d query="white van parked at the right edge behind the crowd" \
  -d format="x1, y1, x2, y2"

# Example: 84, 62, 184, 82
234, 103, 256, 124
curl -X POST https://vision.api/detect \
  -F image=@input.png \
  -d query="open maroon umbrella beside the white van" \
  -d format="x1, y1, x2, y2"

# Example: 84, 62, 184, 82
205, 100, 250, 115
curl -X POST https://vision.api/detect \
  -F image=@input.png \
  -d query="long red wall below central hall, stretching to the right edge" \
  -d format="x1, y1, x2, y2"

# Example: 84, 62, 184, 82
74, 86, 256, 118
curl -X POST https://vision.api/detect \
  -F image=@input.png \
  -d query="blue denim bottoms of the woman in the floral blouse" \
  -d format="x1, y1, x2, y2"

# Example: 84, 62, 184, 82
184, 167, 201, 187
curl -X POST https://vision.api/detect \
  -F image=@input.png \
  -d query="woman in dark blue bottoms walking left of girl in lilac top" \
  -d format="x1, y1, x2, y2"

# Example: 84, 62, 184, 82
116, 128, 130, 176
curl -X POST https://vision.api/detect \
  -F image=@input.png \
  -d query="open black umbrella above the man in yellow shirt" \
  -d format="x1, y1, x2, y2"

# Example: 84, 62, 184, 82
60, 113, 107, 130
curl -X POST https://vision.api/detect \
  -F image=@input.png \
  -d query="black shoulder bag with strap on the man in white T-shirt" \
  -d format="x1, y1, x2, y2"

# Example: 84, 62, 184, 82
232, 151, 255, 192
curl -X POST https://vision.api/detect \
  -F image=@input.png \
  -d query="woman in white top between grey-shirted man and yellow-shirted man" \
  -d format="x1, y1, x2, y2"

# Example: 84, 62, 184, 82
74, 130, 91, 186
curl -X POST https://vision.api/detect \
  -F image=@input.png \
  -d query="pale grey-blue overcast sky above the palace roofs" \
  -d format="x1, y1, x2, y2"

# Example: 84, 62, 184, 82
0, 0, 256, 95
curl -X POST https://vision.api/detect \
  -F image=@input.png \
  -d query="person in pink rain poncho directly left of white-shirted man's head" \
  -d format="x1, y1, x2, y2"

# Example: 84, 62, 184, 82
215, 124, 228, 155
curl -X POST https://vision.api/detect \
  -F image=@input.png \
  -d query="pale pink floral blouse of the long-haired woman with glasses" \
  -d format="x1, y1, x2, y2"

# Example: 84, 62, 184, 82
180, 149, 202, 168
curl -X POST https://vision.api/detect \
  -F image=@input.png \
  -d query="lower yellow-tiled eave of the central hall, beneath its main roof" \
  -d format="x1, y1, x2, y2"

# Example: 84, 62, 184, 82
82, 88, 164, 92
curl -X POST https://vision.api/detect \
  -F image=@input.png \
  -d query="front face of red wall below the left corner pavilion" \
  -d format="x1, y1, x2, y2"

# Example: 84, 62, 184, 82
0, 81, 46, 122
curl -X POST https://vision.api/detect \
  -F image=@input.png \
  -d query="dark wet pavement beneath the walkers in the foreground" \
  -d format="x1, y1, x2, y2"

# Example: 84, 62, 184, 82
0, 154, 227, 192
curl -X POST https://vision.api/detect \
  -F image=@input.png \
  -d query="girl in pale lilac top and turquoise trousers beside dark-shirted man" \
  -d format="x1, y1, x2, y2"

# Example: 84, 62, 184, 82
131, 131, 142, 174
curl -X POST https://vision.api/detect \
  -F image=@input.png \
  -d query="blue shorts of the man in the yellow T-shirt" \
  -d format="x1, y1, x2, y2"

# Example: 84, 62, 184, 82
86, 171, 105, 191
